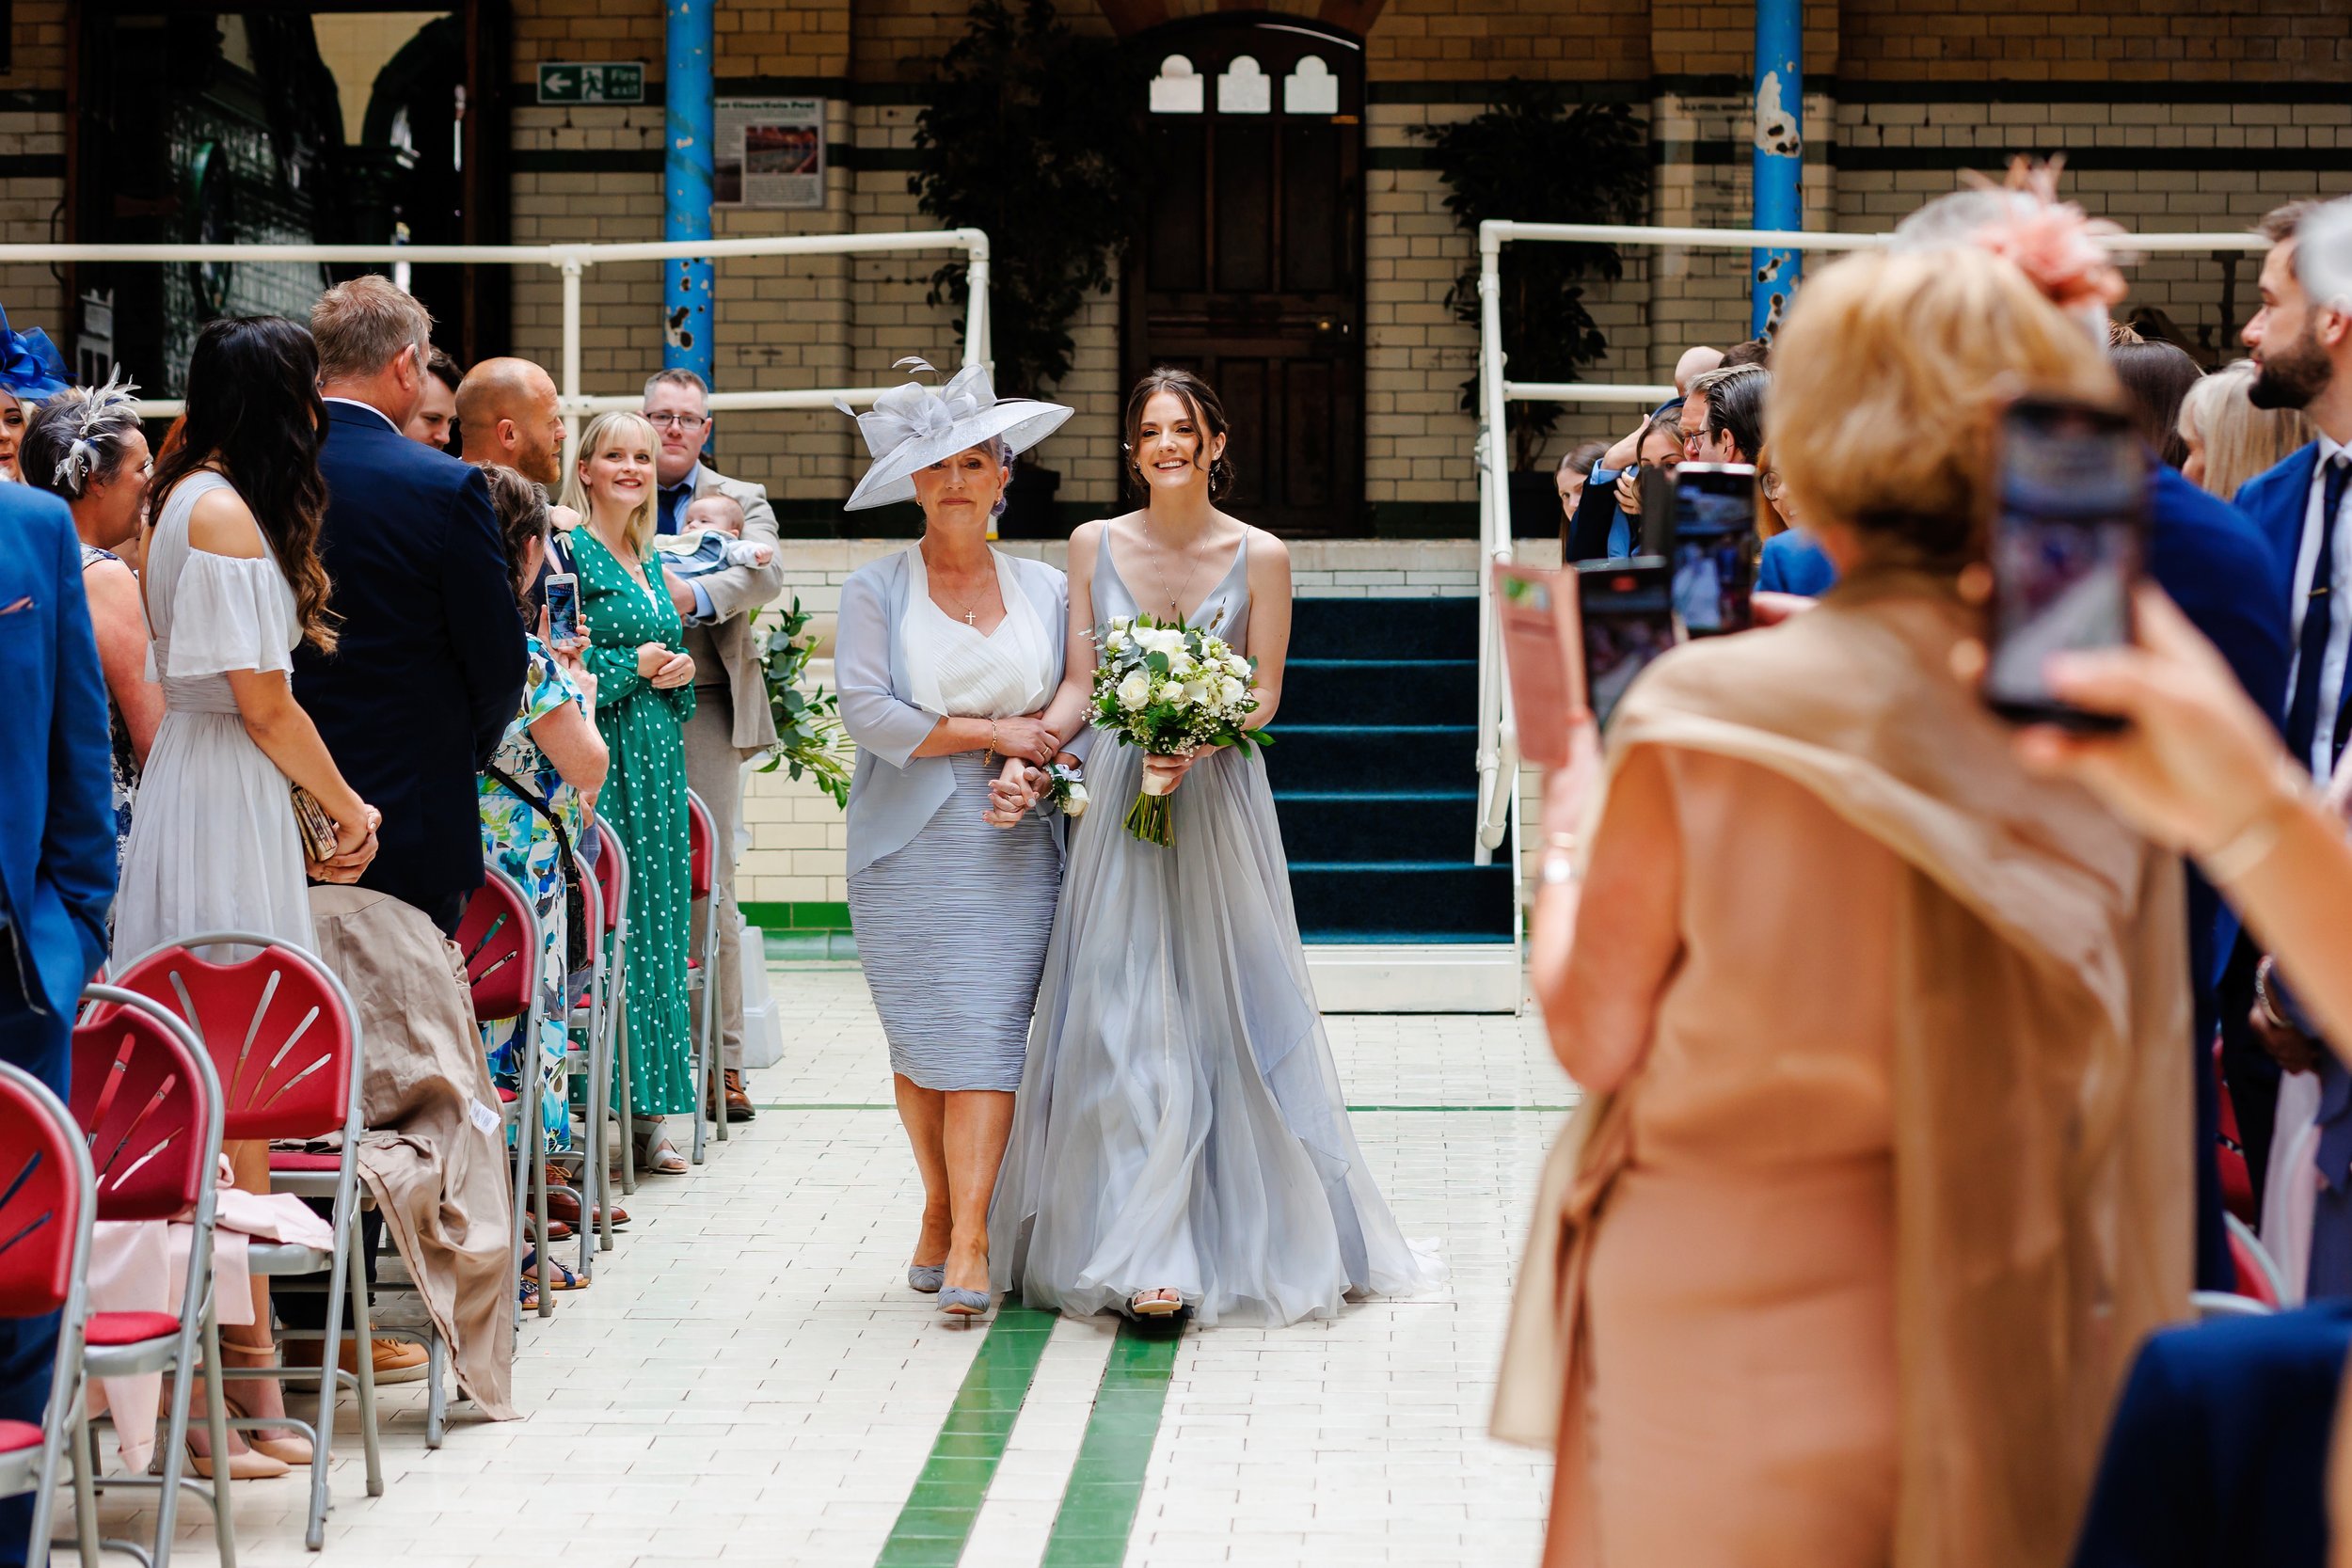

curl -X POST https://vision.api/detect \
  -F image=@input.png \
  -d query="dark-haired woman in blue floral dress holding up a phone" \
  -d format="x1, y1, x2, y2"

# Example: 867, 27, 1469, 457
478, 467, 607, 1149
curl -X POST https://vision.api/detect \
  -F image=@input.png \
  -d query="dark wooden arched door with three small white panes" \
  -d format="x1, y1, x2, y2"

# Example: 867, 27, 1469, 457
1122, 16, 1364, 536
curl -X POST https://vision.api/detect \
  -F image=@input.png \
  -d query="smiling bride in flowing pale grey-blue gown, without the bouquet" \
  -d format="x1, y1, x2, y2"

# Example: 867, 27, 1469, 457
988, 372, 1444, 1323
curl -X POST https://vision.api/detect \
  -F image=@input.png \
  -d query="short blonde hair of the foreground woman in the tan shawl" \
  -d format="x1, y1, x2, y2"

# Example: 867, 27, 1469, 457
1772, 245, 2120, 574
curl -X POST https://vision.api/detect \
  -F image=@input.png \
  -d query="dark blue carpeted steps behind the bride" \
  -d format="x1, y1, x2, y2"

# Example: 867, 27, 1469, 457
1265, 597, 1513, 942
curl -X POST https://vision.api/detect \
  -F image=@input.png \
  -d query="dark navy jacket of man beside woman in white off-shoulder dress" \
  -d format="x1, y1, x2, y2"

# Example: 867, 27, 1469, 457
294, 402, 525, 912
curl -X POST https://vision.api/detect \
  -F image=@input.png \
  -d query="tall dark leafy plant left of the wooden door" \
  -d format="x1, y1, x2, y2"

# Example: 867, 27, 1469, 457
908, 0, 1143, 538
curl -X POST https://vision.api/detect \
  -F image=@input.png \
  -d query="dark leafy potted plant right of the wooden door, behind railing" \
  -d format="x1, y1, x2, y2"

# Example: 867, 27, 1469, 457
1416, 77, 1651, 533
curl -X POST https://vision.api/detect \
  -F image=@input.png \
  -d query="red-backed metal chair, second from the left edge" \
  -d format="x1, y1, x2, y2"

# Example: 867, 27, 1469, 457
73, 985, 238, 1568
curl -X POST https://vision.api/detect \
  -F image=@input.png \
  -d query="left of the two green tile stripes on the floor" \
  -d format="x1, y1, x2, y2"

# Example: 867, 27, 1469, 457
875, 1303, 1054, 1568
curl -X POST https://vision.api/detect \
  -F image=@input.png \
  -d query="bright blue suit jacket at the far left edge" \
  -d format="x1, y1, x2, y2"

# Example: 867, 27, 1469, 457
0, 484, 116, 1020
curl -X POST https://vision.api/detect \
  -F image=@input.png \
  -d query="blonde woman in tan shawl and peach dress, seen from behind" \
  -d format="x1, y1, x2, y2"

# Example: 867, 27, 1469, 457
1496, 251, 2190, 1568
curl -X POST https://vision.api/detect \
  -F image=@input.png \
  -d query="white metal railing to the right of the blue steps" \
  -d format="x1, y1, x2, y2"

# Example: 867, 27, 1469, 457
1475, 218, 2270, 907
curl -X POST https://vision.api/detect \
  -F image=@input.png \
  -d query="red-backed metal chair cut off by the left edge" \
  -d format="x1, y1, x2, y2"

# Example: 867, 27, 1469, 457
0, 1063, 99, 1568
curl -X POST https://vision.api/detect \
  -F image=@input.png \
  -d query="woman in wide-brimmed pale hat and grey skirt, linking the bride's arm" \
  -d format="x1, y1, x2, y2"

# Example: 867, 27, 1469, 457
833, 362, 1082, 1314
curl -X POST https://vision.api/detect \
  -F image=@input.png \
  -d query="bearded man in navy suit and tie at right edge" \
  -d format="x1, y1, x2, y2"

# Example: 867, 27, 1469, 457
2223, 202, 2352, 1259
